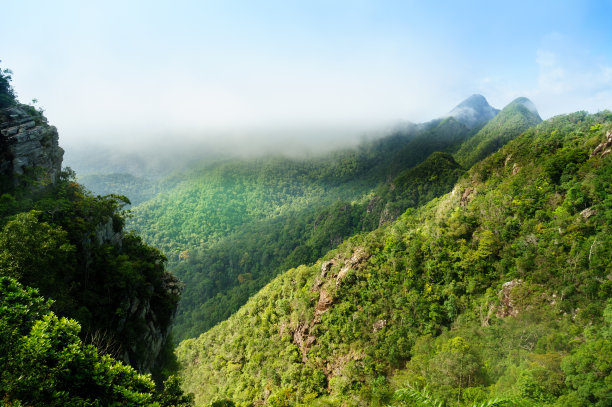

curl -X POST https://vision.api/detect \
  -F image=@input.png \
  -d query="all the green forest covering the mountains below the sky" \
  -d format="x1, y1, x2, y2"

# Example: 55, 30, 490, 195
0, 59, 612, 407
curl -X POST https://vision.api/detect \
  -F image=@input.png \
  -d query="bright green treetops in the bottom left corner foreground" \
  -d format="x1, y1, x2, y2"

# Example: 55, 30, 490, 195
0, 277, 193, 406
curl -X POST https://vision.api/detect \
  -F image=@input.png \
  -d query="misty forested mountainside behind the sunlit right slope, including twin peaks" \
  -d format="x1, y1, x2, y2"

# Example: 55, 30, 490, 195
124, 95, 539, 340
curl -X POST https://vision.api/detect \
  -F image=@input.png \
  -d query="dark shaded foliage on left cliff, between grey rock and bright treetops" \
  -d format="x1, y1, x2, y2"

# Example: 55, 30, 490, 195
0, 172, 178, 374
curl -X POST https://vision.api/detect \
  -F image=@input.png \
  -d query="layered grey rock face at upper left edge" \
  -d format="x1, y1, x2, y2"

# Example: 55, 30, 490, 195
0, 105, 64, 188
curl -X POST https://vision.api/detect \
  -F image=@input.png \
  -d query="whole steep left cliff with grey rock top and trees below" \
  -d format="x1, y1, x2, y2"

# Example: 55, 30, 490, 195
0, 63, 192, 406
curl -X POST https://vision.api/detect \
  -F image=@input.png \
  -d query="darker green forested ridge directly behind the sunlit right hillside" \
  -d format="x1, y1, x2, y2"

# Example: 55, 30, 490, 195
173, 153, 463, 339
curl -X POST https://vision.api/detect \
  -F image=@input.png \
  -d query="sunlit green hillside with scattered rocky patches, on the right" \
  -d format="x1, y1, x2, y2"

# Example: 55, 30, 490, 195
177, 111, 612, 406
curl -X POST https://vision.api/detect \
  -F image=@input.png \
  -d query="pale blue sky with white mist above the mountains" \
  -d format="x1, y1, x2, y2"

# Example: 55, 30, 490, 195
0, 0, 612, 150
